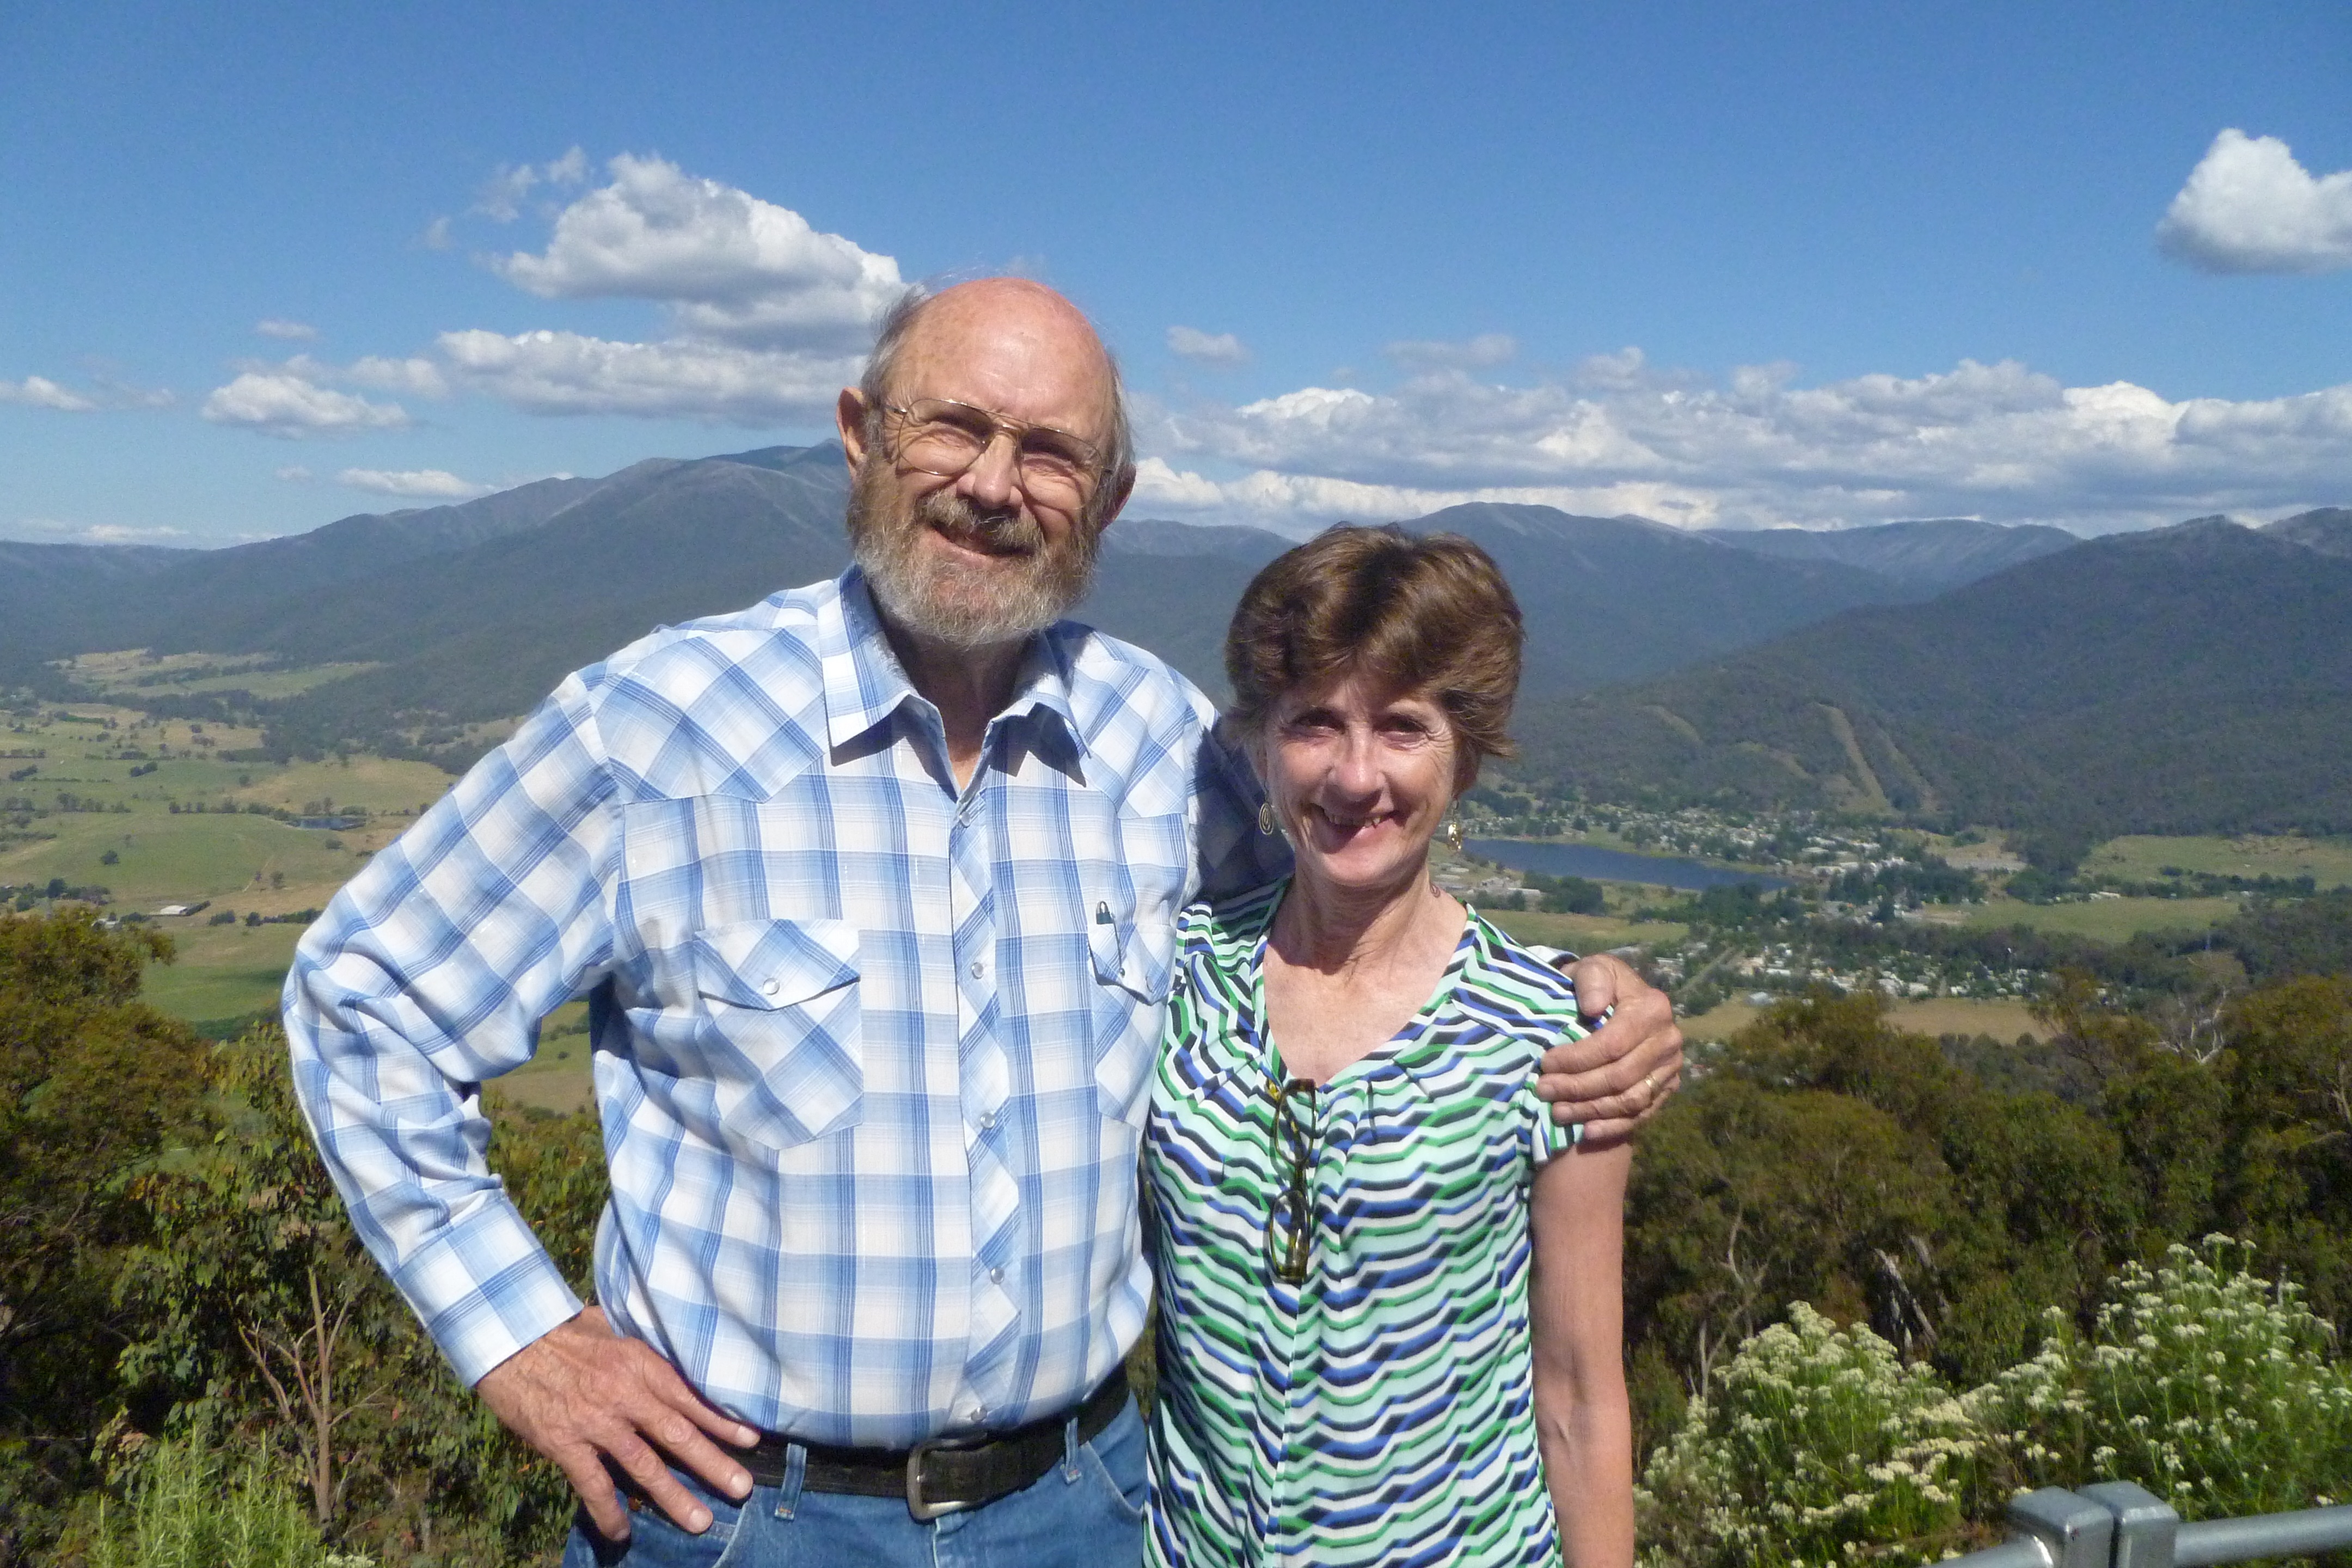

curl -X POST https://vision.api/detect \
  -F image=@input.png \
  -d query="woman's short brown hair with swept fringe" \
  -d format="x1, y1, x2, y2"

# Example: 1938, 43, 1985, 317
1226, 524, 1527, 787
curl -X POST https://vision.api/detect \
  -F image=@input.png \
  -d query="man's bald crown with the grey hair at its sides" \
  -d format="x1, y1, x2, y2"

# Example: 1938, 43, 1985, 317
859, 278, 1136, 510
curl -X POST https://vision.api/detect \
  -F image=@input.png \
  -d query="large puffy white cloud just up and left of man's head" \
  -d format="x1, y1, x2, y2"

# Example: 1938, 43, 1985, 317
492, 153, 903, 353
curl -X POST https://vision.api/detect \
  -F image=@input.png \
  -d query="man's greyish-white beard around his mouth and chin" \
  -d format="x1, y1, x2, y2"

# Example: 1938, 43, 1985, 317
849, 454, 1101, 649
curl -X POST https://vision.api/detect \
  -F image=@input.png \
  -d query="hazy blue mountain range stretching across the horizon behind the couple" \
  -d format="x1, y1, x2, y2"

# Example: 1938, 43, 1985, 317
0, 444, 2352, 846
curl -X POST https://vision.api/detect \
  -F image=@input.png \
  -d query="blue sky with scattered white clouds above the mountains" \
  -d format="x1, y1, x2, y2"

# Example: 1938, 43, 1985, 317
0, 0, 2352, 546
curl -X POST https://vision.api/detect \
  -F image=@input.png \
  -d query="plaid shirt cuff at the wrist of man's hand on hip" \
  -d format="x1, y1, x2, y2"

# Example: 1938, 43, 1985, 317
393, 1192, 581, 1387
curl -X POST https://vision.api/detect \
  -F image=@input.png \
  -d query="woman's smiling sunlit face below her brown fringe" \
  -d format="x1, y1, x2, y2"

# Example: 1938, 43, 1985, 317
1261, 675, 1461, 891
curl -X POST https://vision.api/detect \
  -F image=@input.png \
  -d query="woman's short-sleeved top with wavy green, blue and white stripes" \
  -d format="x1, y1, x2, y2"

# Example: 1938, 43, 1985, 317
1143, 884, 1583, 1568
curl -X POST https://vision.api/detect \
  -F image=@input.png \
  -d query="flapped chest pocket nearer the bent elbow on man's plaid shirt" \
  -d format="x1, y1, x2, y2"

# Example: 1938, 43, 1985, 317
694, 919, 866, 1149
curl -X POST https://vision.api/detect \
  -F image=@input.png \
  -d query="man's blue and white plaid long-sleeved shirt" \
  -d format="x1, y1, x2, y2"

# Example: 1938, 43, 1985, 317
287, 571, 1287, 1448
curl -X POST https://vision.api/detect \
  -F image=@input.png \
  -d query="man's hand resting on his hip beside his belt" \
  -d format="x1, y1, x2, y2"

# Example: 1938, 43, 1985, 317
473, 1307, 759, 1540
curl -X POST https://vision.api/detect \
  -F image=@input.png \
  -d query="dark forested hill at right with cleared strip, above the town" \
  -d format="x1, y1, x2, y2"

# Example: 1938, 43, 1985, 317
1522, 519, 2352, 842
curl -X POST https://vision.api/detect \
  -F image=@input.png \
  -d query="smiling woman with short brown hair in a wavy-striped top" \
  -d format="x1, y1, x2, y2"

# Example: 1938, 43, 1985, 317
1146, 526, 1632, 1568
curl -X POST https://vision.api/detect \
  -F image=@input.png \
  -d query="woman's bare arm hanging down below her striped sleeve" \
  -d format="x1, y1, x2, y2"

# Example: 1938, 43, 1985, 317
1529, 1140, 1632, 1568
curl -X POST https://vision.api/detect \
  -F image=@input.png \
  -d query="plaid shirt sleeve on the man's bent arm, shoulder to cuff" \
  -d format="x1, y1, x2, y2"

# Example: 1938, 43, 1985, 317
285, 677, 616, 1385
